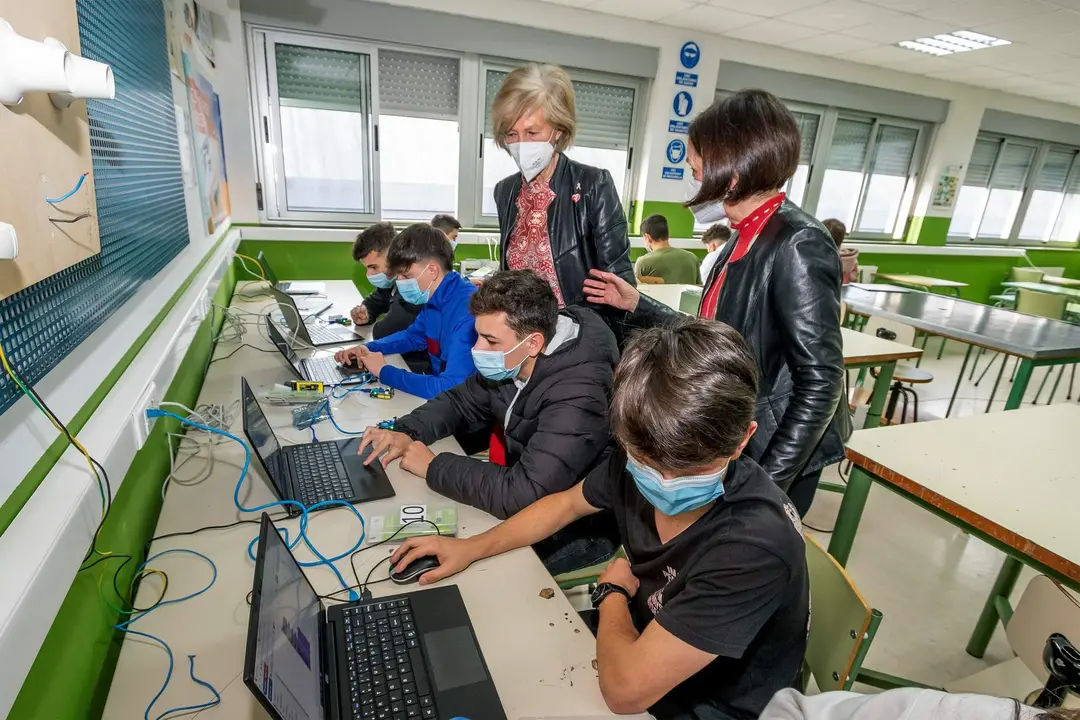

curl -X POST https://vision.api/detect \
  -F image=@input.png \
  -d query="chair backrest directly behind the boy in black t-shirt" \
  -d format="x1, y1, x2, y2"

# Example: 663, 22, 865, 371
806, 535, 881, 692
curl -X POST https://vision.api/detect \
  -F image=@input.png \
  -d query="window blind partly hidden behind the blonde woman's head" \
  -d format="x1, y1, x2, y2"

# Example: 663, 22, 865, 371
484, 70, 635, 150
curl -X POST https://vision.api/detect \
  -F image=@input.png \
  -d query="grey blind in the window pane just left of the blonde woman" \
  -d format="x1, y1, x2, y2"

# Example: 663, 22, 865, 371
379, 50, 461, 120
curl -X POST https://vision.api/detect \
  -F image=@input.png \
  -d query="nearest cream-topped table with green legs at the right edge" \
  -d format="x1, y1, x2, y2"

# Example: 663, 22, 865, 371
828, 403, 1080, 657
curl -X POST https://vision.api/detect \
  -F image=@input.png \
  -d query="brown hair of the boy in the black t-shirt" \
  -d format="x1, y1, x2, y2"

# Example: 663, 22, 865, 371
610, 317, 759, 472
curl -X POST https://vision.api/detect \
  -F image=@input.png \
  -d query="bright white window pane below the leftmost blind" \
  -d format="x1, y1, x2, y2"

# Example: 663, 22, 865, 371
280, 105, 368, 213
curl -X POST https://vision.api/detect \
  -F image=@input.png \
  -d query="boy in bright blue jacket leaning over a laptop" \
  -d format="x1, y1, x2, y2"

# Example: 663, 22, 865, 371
335, 222, 476, 399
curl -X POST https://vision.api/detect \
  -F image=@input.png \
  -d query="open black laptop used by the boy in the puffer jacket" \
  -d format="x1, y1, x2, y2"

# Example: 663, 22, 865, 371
240, 379, 394, 515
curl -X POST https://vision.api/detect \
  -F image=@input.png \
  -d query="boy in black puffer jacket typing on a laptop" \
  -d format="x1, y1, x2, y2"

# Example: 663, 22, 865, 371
361, 270, 619, 574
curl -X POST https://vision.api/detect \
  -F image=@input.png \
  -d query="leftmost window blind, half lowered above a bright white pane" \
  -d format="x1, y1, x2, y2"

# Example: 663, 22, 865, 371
274, 43, 369, 112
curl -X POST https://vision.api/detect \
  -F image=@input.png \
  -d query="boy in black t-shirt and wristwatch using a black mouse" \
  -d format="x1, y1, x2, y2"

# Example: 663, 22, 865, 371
393, 318, 810, 720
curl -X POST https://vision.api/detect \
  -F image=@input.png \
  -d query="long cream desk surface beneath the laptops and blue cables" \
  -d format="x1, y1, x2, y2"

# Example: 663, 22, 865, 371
104, 282, 626, 720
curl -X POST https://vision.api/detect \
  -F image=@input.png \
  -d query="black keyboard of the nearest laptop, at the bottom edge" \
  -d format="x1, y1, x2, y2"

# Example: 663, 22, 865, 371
345, 599, 438, 720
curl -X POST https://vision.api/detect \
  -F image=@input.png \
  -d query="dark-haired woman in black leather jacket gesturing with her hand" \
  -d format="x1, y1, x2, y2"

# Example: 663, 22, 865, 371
585, 90, 851, 516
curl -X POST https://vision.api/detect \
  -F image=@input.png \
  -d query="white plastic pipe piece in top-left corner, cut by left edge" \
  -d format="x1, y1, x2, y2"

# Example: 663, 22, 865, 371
0, 18, 72, 105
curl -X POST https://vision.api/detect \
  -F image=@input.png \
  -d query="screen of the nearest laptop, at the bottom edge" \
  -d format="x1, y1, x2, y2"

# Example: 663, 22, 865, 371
246, 515, 328, 720
